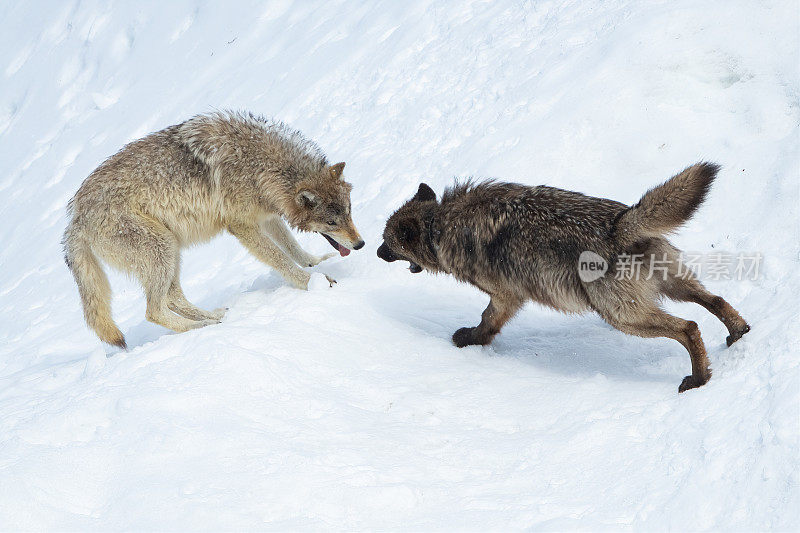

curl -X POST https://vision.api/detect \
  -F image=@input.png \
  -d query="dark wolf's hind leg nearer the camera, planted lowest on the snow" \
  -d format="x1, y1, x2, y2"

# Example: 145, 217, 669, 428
601, 305, 711, 392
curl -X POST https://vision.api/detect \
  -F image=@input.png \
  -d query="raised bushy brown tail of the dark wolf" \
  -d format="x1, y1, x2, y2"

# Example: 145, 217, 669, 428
613, 163, 720, 245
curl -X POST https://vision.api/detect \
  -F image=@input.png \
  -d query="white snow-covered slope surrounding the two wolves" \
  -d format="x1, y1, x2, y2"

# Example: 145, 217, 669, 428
0, 0, 800, 530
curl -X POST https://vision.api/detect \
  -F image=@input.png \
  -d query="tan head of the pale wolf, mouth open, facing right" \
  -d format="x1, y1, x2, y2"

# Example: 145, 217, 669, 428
292, 163, 364, 256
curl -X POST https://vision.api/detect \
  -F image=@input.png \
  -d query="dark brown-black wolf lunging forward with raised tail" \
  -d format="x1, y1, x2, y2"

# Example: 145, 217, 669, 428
378, 163, 750, 392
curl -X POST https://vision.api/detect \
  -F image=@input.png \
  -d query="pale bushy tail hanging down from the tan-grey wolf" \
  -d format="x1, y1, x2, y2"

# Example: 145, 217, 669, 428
64, 230, 127, 349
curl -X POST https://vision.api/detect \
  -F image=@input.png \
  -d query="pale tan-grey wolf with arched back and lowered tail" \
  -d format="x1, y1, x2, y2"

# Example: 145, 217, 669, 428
63, 111, 364, 348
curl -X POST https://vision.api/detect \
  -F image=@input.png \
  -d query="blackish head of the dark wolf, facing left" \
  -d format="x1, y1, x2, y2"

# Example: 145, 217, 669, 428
378, 183, 440, 274
